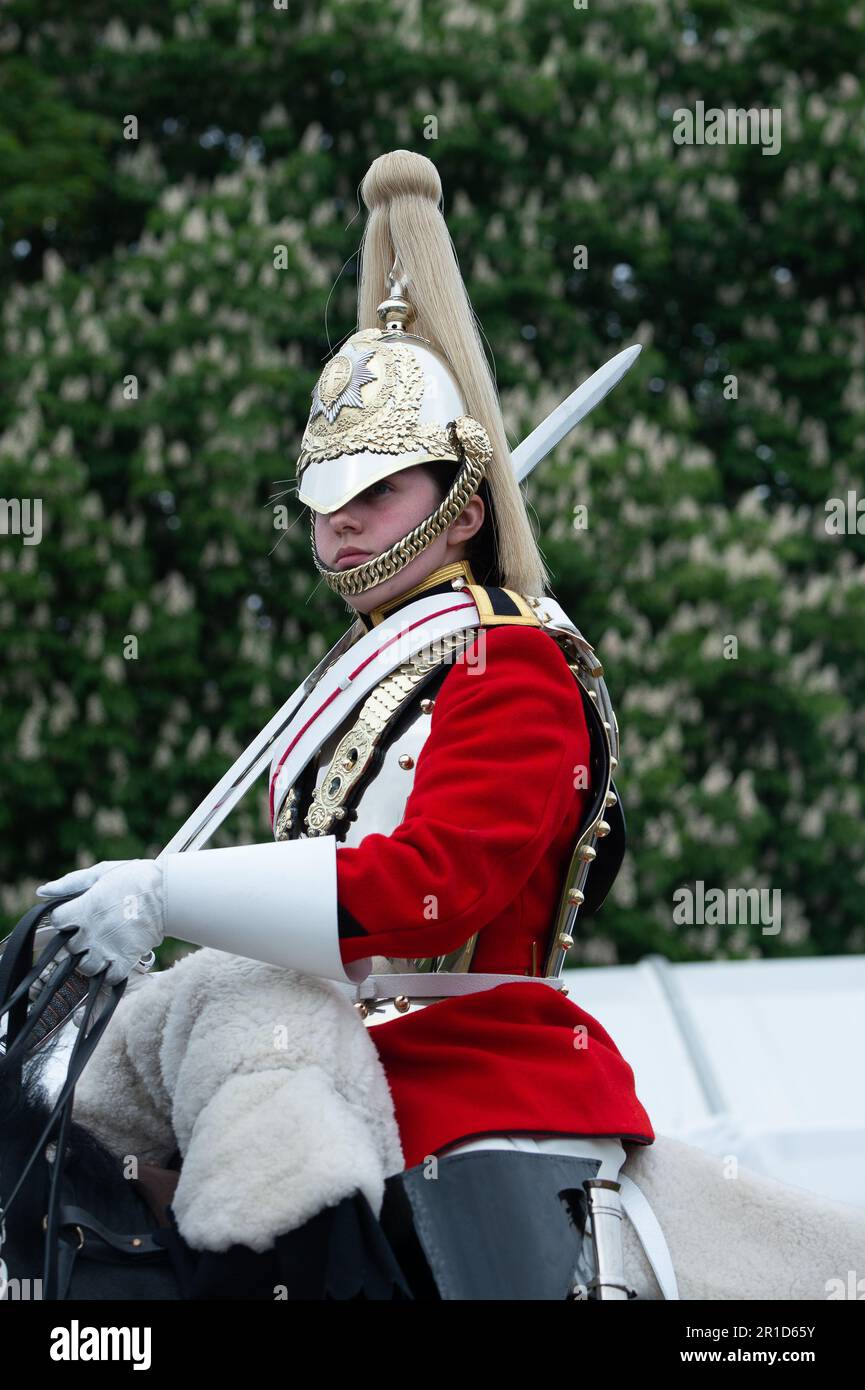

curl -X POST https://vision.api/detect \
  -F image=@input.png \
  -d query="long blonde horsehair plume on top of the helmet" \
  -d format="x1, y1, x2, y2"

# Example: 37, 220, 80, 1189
357, 150, 548, 596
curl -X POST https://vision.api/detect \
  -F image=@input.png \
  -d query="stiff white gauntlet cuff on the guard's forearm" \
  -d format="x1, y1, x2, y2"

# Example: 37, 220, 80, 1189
159, 835, 371, 984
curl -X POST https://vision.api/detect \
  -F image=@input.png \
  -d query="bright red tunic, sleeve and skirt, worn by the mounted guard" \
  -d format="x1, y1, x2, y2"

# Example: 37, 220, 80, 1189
337, 624, 655, 1168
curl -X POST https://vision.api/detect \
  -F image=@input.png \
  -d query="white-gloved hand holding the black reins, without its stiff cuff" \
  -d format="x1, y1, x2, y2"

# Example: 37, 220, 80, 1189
36, 859, 165, 984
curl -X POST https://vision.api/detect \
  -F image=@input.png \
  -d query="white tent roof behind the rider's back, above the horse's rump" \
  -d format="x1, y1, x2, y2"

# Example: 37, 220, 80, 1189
565, 955, 865, 1207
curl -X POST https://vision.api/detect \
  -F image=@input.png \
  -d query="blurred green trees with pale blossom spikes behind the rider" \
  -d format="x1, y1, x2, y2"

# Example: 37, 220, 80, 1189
0, 0, 865, 962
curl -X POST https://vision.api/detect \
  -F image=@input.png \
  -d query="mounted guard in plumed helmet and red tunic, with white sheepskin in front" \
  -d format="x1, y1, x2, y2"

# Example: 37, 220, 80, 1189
13, 150, 655, 1298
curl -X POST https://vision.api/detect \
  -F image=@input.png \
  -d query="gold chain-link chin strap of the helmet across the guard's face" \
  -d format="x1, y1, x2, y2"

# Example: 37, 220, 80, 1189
310, 416, 492, 598
